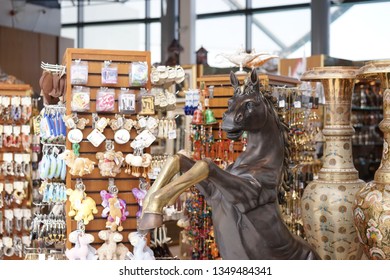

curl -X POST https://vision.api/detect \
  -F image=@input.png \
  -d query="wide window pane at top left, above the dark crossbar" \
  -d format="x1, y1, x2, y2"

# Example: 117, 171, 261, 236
84, 0, 145, 22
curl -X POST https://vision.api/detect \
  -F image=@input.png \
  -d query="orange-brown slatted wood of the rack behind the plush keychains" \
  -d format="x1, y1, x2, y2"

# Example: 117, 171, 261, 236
63, 48, 150, 248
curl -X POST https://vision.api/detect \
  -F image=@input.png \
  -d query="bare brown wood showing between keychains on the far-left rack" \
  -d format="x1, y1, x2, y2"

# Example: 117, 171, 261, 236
0, 84, 33, 260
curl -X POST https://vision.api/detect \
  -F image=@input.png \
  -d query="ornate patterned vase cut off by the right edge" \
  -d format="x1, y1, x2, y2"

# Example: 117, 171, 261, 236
353, 60, 390, 259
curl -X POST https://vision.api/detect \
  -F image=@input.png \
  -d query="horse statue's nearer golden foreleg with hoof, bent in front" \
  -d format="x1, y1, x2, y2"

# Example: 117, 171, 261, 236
139, 160, 209, 231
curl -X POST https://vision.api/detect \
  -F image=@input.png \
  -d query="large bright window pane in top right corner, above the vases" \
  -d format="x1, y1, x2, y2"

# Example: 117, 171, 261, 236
330, 2, 390, 60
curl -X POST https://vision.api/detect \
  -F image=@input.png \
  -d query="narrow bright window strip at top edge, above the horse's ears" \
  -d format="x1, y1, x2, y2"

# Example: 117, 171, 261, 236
195, 0, 246, 14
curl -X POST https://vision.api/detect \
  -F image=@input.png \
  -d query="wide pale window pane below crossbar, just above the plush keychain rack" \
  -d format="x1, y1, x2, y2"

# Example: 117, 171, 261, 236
84, 24, 145, 51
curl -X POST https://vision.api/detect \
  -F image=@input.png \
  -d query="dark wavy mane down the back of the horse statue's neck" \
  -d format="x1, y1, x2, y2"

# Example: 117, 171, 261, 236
260, 88, 290, 190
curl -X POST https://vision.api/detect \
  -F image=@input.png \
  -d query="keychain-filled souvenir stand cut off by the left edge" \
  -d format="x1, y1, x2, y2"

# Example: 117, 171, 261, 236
0, 84, 32, 259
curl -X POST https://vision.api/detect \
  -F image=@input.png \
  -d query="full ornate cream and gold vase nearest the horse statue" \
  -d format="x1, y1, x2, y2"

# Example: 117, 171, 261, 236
301, 67, 365, 260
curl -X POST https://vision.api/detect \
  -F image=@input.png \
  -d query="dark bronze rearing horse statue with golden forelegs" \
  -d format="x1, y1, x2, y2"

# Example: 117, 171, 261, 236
139, 70, 320, 260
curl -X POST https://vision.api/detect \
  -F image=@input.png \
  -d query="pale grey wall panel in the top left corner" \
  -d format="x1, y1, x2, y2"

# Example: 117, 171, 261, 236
0, 0, 61, 36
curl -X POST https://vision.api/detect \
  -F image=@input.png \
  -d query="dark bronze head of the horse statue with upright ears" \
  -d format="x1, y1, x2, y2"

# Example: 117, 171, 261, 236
222, 70, 267, 140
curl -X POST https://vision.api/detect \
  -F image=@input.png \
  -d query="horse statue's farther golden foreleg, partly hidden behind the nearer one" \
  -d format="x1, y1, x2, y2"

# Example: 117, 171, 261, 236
142, 155, 180, 214
